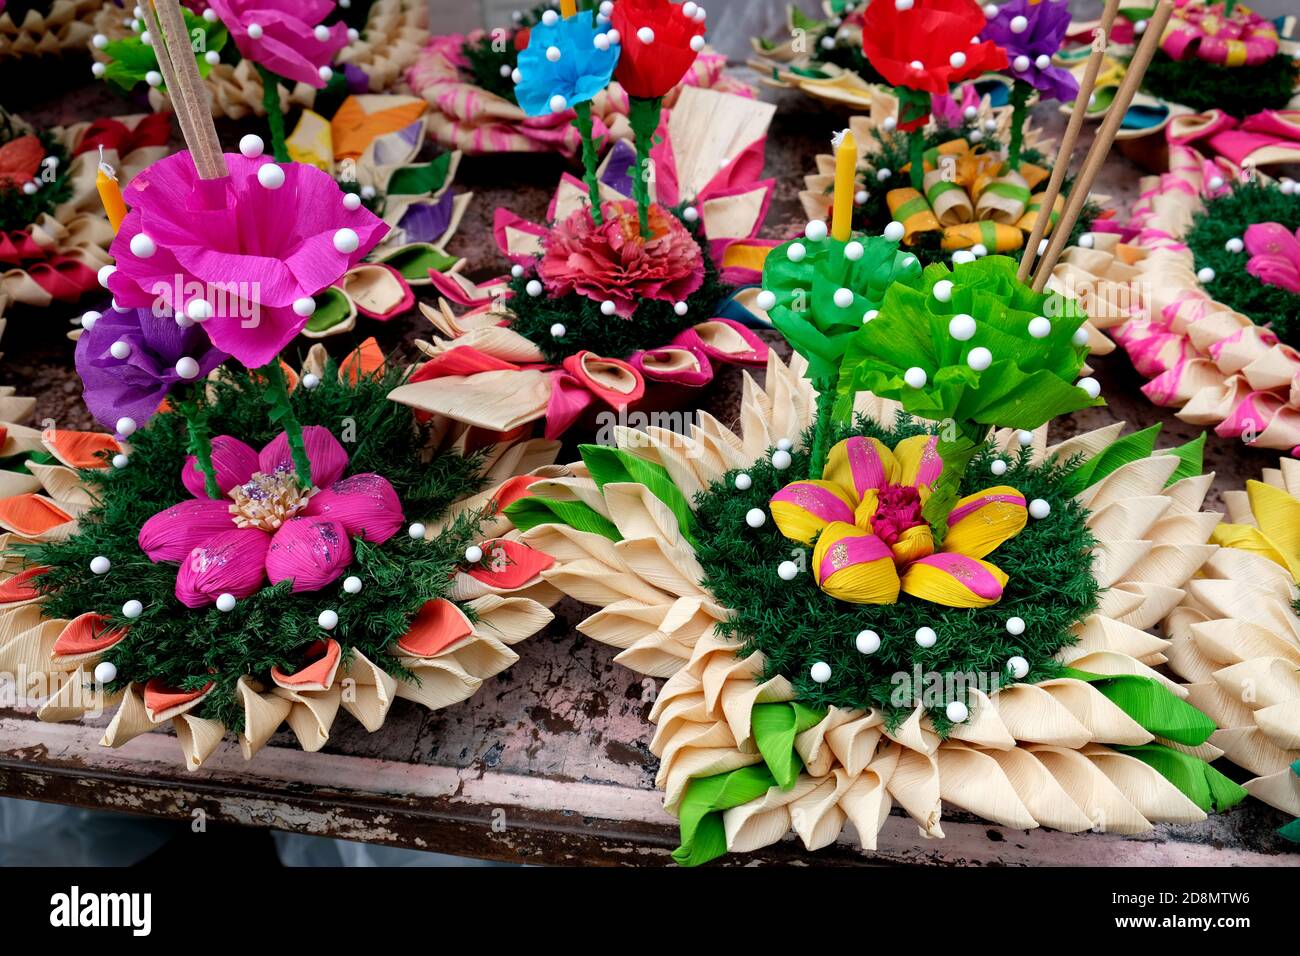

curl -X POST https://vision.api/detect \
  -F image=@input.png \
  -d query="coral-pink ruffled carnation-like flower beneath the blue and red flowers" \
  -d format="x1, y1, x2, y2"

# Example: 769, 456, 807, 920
537, 202, 705, 319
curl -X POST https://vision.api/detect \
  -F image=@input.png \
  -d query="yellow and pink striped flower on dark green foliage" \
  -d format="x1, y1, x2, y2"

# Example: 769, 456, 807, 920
770, 434, 1028, 607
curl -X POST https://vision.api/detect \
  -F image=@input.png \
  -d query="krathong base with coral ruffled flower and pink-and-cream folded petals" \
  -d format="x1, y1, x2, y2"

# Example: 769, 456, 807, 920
394, 87, 775, 438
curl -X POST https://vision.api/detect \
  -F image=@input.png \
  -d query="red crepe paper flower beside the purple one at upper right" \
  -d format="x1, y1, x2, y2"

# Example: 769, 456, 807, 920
862, 0, 1006, 97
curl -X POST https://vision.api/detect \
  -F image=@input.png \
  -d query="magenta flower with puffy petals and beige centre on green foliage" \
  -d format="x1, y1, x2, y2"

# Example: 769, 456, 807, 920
139, 425, 403, 607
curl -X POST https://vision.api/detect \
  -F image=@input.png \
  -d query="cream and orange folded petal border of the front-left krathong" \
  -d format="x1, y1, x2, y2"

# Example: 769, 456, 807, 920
0, 374, 564, 770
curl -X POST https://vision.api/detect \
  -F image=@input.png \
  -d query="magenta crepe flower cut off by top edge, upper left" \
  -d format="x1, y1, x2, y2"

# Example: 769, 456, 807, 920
208, 0, 347, 90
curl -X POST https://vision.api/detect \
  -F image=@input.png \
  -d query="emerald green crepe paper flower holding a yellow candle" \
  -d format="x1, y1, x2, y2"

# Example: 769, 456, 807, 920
763, 235, 922, 387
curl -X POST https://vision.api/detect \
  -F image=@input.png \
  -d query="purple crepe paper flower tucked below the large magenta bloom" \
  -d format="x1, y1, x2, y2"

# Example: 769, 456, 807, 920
75, 307, 228, 429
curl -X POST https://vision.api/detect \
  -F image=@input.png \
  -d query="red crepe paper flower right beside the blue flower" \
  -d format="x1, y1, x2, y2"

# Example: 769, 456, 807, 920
612, 0, 705, 100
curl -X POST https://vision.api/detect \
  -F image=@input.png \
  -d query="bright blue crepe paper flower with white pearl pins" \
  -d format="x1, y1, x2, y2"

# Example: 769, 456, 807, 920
515, 10, 619, 116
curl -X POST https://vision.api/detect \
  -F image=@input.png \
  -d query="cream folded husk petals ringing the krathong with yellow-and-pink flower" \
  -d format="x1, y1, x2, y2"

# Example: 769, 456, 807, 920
523, 356, 1218, 851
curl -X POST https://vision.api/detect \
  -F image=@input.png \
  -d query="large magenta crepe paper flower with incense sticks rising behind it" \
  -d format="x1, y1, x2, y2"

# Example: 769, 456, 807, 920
108, 152, 389, 368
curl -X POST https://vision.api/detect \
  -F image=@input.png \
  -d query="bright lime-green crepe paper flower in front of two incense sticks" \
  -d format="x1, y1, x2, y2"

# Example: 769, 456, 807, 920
835, 256, 1104, 538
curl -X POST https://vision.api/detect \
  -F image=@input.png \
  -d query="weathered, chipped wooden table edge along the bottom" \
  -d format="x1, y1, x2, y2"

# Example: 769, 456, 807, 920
0, 711, 1300, 866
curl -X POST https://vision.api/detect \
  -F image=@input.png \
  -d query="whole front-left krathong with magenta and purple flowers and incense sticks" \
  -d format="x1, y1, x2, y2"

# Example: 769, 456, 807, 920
0, 0, 558, 769
